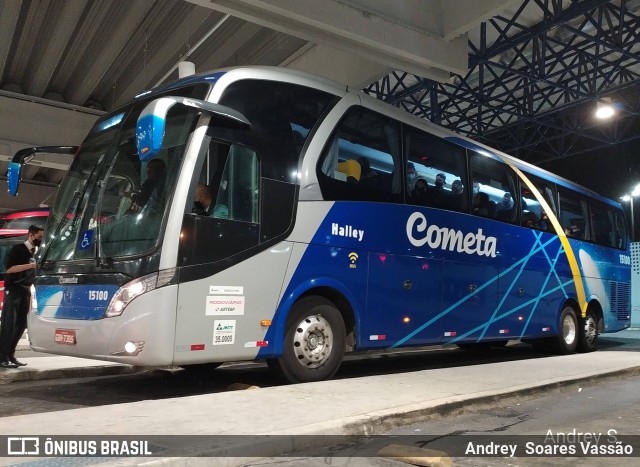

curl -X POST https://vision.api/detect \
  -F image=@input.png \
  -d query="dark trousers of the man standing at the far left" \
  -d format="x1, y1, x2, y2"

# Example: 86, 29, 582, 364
0, 288, 31, 361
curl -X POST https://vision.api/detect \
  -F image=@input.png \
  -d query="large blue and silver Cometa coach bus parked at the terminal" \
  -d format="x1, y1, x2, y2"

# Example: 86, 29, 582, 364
9, 67, 630, 382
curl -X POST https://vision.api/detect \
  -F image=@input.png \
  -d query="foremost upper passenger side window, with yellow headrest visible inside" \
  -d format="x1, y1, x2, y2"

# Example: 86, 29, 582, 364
319, 107, 402, 202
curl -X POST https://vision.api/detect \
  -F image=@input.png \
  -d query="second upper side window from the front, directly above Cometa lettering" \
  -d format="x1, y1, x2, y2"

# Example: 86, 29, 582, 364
405, 126, 468, 212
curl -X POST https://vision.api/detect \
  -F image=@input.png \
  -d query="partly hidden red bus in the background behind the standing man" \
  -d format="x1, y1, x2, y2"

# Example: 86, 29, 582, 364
0, 208, 49, 313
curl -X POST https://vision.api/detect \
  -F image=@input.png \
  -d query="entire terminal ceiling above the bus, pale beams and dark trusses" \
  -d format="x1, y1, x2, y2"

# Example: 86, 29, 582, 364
0, 0, 640, 205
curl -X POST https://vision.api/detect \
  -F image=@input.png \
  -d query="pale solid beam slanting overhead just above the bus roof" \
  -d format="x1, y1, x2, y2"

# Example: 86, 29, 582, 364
189, 0, 476, 84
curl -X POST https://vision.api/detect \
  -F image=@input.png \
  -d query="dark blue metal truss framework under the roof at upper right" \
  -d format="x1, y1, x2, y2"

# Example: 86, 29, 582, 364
364, 0, 640, 165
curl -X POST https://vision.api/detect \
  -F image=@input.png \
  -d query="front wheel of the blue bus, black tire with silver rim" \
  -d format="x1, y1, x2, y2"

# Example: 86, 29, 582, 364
267, 296, 346, 383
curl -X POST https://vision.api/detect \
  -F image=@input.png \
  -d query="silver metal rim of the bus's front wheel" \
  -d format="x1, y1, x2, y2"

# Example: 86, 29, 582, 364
293, 315, 333, 368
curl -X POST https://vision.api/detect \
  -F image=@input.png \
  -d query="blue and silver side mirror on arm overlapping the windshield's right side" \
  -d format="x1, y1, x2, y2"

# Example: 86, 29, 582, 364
136, 96, 251, 162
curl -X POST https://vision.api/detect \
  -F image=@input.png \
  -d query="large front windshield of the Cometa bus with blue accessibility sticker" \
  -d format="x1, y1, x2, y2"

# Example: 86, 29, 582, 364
43, 86, 205, 262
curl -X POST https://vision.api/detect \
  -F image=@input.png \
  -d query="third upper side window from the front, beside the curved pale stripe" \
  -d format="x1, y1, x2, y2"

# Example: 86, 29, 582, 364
470, 152, 518, 223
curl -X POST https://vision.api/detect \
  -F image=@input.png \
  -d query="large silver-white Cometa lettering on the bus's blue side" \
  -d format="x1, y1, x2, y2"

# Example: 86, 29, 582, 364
407, 212, 498, 258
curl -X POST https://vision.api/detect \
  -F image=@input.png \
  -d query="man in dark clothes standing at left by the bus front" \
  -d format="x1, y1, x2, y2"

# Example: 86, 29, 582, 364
0, 225, 44, 368
